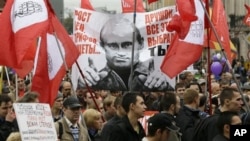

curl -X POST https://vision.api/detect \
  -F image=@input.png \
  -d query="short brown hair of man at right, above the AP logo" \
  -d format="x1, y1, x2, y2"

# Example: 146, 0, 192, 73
219, 87, 239, 106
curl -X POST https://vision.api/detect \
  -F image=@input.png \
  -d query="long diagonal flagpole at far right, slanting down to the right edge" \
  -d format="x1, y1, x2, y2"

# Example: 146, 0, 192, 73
200, 0, 250, 112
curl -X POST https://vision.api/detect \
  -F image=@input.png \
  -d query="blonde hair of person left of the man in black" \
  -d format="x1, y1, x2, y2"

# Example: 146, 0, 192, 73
83, 109, 101, 127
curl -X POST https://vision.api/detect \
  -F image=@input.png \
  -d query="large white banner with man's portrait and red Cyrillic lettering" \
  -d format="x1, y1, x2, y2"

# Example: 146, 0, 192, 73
72, 6, 176, 91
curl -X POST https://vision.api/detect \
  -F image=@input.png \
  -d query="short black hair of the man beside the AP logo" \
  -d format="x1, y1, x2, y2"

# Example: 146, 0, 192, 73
217, 111, 239, 134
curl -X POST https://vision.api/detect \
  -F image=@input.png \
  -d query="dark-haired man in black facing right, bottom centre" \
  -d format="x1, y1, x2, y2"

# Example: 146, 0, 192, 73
107, 92, 147, 141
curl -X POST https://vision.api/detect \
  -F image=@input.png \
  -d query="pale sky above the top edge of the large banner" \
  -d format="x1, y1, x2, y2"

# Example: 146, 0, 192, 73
64, 0, 121, 12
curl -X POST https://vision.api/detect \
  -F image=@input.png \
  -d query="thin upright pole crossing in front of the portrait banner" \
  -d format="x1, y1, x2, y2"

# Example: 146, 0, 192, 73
128, 0, 137, 92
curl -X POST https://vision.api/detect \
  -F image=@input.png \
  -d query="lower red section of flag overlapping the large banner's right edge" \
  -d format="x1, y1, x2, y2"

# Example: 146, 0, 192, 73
161, 34, 202, 78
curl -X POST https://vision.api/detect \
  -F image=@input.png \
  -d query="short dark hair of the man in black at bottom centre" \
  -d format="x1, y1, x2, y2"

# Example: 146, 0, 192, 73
122, 92, 141, 113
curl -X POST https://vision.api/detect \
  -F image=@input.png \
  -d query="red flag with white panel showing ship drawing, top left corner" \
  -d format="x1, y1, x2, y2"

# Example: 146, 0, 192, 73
0, 0, 48, 77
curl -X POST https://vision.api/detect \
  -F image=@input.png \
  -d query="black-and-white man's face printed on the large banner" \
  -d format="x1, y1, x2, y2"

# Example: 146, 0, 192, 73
102, 18, 141, 69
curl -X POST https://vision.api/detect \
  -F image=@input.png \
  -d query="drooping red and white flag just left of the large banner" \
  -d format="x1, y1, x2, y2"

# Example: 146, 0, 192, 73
32, 12, 79, 104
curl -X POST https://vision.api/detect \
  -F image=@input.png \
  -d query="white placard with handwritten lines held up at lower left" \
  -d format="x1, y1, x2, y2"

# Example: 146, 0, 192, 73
13, 103, 57, 141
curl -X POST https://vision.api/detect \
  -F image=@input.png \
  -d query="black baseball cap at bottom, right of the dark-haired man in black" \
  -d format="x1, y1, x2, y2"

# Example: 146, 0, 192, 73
148, 113, 179, 131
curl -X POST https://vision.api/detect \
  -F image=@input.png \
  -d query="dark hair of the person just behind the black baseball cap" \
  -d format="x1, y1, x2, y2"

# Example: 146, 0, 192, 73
160, 92, 177, 110
